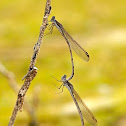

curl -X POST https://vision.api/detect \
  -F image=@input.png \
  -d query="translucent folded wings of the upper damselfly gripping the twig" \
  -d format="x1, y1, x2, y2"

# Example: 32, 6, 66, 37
62, 28, 89, 61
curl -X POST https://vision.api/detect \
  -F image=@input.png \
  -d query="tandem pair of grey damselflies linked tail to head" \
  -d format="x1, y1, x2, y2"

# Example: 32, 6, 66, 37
46, 16, 97, 126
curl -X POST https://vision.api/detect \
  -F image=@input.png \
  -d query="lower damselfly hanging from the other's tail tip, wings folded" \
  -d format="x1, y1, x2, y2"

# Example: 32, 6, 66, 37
52, 75, 97, 126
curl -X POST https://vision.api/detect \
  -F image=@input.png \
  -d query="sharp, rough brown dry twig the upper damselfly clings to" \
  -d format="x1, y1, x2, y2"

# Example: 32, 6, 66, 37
8, 0, 51, 126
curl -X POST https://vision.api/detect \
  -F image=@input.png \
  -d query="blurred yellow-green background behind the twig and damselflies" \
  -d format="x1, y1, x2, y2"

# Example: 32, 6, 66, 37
0, 0, 126, 126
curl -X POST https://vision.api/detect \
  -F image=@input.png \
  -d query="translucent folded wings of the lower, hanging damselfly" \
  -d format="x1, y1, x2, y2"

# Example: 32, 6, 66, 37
72, 89, 97, 126
